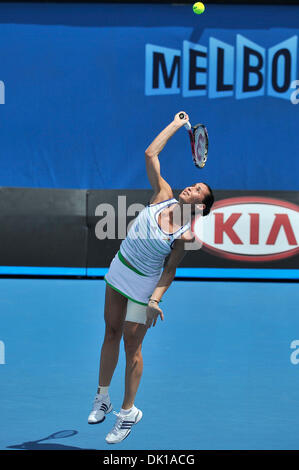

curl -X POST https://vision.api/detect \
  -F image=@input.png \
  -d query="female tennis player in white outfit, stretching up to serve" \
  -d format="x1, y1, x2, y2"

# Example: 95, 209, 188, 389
88, 113, 214, 444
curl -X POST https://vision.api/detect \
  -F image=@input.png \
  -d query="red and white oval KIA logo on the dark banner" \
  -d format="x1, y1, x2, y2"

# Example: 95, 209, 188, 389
192, 196, 299, 262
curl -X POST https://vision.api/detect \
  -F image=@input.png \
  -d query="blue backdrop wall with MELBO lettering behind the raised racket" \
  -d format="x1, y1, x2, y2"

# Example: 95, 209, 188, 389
0, 4, 299, 190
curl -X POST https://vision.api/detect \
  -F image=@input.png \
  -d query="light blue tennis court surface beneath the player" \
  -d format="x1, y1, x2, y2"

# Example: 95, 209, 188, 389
0, 279, 299, 450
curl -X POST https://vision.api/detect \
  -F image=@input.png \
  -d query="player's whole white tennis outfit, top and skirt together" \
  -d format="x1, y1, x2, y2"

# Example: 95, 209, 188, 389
105, 198, 190, 323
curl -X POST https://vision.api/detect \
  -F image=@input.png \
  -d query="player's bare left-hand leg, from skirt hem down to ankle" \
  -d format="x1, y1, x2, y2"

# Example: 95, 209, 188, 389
99, 285, 127, 387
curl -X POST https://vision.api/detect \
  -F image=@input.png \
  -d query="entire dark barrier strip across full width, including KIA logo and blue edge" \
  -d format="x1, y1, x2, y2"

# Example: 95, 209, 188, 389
0, 188, 299, 279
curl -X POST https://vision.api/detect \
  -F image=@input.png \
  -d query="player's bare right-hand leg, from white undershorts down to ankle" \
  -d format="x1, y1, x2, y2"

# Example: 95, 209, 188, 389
122, 321, 148, 410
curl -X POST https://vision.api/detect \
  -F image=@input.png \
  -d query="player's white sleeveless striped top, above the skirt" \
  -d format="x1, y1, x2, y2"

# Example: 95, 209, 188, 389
120, 198, 190, 276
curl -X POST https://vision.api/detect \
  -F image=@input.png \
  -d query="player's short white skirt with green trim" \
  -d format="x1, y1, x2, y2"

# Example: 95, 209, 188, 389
104, 253, 161, 316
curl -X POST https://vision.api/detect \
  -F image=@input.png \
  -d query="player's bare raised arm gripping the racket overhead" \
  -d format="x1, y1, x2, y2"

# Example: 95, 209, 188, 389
145, 111, 189, 204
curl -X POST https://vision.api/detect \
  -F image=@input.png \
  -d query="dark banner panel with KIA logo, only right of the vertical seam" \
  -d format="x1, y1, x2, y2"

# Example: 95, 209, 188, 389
88, 190, 299, 279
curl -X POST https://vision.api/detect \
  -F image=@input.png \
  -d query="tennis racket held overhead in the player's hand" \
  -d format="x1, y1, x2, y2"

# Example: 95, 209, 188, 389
179, 113, 209, 169
